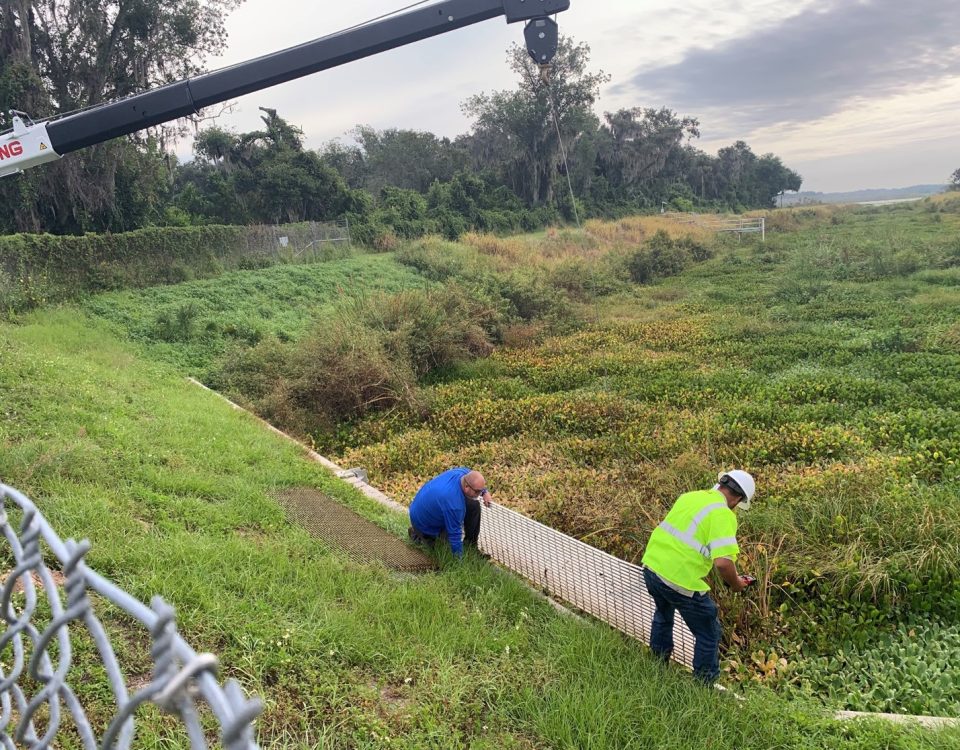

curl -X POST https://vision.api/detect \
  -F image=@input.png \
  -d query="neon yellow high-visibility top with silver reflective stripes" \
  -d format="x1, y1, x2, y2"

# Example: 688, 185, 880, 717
642, 490, 740, 591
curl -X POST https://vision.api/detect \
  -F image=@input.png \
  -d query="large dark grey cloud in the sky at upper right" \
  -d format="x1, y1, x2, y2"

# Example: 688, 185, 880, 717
618, 0, 960, 135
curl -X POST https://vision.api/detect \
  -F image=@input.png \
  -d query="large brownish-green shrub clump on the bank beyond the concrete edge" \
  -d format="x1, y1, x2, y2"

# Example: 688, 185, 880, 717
206, 285, 503, 436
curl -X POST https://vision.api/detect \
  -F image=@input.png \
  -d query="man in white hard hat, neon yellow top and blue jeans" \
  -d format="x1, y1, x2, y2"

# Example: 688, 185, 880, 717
643, 469, 756, 685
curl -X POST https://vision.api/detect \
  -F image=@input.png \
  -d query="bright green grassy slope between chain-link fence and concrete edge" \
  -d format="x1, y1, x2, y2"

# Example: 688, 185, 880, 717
0, 310, 958, 748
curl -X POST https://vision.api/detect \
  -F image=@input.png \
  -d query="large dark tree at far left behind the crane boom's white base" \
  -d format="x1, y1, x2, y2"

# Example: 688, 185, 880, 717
0, 0, 241, 233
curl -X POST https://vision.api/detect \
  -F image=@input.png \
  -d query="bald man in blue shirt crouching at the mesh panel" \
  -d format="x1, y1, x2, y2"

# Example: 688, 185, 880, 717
408, 466, 493, 557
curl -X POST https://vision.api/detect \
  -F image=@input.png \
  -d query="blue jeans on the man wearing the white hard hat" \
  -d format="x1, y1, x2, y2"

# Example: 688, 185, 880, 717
643, 568, 721, 685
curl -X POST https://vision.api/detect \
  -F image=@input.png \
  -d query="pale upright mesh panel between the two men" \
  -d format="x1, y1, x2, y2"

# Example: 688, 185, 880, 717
479, 504, 693, 667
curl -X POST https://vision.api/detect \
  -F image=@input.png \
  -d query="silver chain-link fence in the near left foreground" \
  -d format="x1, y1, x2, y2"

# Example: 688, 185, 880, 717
0, 484, 262, 750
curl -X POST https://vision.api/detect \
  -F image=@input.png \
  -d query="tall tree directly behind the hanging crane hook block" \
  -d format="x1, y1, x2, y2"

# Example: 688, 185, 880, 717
458, 37, 610, 205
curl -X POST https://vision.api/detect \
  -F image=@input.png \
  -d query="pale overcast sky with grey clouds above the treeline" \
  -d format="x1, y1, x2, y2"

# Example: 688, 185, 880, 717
181, 0, 960, 192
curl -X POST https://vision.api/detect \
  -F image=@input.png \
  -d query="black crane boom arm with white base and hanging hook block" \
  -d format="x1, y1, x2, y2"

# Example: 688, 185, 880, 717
0, 0, 570, 177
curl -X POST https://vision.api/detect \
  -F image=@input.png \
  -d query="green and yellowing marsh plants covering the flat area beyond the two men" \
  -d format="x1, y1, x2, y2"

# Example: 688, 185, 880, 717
332, 206, 960, 715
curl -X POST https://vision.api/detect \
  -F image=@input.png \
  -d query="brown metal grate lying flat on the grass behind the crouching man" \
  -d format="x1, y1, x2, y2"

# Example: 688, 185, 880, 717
274, 487, 436, 573
